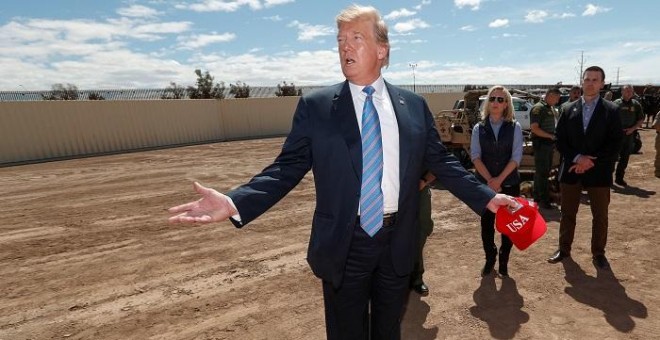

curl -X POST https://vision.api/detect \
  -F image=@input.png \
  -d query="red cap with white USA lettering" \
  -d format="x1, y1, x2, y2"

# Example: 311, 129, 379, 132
495, 197, 547, 250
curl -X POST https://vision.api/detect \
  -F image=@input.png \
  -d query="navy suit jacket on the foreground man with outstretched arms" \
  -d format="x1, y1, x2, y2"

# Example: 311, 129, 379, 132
227, 81, 495, 287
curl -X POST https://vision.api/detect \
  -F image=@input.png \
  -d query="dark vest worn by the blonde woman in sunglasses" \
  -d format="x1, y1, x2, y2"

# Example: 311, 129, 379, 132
477, 118, 520, 186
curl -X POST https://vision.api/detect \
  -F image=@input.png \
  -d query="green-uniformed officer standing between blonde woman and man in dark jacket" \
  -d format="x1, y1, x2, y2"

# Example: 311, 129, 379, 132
530, 87, 561, 209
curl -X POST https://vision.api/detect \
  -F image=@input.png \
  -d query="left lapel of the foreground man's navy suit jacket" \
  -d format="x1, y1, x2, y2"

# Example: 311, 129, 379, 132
331, 81, 362, 180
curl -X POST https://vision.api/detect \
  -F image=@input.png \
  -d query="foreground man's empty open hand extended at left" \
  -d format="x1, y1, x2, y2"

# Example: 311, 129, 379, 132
168, 182, 238, 223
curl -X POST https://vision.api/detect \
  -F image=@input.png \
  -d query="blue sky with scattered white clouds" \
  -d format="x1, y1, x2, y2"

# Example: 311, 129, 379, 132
0, 0, 660, 91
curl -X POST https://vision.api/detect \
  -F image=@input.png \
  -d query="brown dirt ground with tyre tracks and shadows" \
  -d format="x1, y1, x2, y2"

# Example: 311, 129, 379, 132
0, 130, 660, 340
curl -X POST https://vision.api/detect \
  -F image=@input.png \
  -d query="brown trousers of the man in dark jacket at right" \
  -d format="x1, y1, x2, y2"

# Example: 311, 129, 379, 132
559, 183, 610, 256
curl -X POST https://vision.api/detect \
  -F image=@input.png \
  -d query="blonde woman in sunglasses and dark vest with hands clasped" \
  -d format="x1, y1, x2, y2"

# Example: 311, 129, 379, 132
470, 85, 523, 277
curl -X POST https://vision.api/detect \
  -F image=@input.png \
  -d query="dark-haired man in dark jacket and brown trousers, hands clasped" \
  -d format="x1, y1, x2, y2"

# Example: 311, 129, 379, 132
548, 66, 623, 270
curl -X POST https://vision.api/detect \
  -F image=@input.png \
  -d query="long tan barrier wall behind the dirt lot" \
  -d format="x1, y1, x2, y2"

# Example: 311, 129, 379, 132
0, 93, 462, 166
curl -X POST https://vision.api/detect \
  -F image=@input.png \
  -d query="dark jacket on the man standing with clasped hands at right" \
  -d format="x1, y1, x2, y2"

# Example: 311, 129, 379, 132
555, 98, 623, 187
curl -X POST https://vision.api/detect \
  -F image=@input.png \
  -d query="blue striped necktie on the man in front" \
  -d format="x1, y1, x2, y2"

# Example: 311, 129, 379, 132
360, 86, 383, 236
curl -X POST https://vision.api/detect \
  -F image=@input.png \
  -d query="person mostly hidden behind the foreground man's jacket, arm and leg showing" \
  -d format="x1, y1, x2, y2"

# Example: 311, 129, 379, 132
410, 171, 435, 296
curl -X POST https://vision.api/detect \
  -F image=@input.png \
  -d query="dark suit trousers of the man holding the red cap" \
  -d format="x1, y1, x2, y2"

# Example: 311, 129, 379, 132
323, 222, 412, 340
